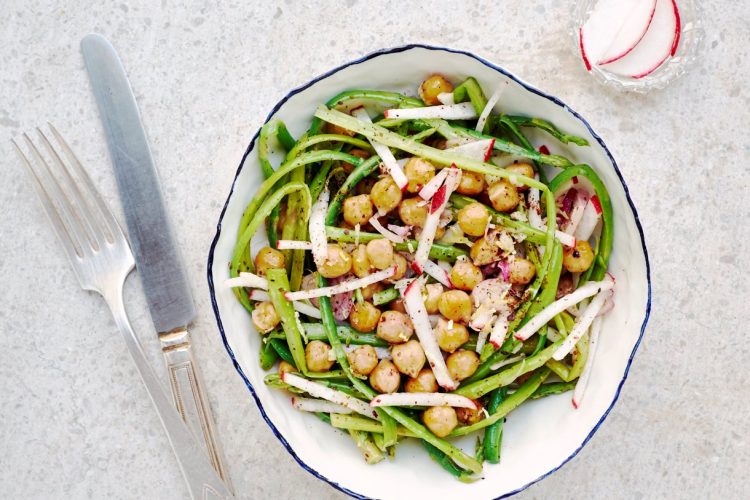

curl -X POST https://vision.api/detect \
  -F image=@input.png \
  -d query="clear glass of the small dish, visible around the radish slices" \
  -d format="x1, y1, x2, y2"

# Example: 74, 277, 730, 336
570, 0, 704, 93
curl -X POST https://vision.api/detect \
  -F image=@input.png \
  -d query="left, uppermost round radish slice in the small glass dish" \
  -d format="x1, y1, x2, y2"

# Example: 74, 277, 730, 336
579, 0, 655, 70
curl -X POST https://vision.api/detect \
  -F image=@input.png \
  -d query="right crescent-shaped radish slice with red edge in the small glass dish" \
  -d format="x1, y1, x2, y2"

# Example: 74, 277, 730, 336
602, 0, 680, 79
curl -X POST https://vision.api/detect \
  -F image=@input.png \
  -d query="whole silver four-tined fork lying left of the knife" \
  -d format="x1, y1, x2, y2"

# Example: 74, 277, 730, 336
11, 124, 233, 500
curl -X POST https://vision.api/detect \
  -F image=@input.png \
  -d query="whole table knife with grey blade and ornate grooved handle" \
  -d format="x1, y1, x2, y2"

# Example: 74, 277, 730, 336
81, 34, 232, 491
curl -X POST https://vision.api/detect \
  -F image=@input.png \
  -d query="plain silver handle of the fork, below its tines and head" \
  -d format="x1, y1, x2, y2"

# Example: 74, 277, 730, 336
105, 292, 234, 500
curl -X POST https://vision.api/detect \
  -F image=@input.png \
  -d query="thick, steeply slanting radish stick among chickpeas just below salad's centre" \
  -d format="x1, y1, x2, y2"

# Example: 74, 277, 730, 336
397, 275, 458, 391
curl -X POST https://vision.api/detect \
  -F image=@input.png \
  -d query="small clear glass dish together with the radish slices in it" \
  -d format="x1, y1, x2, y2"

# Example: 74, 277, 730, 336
570, 0, 704, 93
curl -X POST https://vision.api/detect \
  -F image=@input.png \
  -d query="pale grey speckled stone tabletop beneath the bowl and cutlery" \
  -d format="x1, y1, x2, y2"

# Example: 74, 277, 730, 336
0, 0, 750, 499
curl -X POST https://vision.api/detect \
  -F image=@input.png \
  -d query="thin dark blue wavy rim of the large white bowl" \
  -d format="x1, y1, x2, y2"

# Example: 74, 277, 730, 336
207, 43, 651, 500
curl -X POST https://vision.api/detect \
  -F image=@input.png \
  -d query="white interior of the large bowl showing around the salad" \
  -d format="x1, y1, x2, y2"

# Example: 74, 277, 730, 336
208, 45, 651, 499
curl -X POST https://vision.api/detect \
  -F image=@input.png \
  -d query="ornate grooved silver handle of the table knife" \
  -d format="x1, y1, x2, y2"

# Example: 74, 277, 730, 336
159, 328, 233, 491
